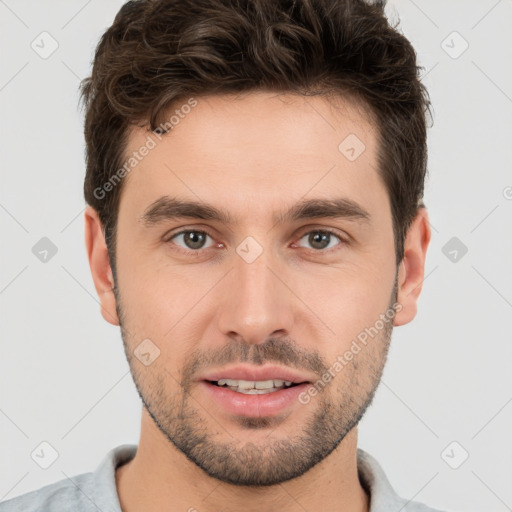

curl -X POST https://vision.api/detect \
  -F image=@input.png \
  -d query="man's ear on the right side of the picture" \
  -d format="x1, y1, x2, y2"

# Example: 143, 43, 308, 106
394, 207, 431, 326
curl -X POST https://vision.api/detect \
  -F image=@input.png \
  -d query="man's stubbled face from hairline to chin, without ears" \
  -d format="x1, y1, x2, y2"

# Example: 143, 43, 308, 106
116, 92, 396, 485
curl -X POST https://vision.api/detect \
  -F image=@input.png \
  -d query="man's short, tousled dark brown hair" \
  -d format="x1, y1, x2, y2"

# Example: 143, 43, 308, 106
81, 0, 429, 275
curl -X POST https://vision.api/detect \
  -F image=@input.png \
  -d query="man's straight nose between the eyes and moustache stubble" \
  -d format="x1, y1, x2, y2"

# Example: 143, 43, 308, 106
218, 243, 294, 344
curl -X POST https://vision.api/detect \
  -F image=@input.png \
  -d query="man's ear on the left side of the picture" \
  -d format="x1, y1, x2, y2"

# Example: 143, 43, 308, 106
84, 206, 119, 325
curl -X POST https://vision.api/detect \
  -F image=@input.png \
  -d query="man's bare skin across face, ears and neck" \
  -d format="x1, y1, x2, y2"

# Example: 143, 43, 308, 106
85, 91, 430, 512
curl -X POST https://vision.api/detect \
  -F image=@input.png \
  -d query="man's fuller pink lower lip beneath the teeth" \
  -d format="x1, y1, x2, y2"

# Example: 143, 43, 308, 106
200, 380, 310, 418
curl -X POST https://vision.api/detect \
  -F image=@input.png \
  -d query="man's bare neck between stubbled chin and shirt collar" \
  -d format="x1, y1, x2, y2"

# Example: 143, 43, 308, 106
116, 409, 369, 512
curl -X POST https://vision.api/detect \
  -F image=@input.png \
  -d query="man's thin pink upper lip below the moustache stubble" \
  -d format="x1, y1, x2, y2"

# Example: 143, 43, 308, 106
199, 365, 314, 384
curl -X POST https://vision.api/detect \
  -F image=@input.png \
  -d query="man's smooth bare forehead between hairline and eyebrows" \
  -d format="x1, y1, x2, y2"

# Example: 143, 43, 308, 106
121, 91, 385, 220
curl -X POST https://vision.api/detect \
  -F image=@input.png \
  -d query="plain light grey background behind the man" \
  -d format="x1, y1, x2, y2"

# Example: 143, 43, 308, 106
0, 0, 512, 512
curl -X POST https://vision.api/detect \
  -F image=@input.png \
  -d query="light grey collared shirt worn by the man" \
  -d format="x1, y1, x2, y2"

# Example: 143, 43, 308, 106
0, 444, 441, 512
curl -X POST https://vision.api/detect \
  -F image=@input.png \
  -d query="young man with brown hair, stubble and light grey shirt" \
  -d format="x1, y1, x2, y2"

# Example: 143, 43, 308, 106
0, 0, 444, 512
